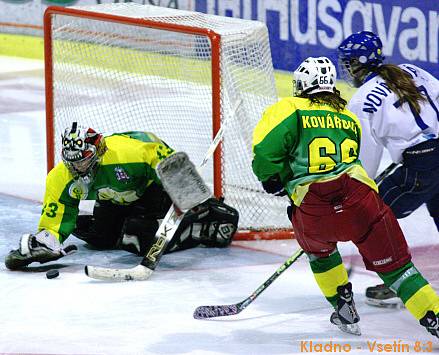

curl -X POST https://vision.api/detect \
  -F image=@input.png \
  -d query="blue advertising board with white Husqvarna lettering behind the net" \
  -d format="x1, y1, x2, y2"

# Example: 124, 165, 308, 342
195, 0, 439, 77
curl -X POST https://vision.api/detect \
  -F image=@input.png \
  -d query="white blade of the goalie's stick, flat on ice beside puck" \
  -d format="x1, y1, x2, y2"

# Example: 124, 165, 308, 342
84, 265, 153, 282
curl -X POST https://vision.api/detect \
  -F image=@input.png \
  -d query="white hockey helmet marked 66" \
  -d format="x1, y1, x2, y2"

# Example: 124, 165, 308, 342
293, 57, 337, 96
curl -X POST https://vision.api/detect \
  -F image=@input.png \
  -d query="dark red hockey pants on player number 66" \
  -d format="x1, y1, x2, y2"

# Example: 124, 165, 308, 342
292, 174, 411, 272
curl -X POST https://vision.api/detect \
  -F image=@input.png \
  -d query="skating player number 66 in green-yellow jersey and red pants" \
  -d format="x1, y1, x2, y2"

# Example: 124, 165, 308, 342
252, 57, 439, 337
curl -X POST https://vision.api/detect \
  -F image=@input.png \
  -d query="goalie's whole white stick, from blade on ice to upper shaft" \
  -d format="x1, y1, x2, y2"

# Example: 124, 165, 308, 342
84, 99, 242, 281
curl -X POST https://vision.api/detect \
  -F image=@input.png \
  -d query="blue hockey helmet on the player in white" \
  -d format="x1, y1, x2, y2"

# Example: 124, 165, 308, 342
338, 31, 384, 86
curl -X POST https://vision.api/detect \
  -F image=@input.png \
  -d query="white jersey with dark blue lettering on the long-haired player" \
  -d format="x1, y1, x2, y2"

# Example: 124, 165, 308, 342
348, 64, 439, 178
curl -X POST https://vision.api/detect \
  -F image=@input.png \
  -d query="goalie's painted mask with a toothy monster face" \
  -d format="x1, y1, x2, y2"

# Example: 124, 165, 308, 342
61, 122, 107, 182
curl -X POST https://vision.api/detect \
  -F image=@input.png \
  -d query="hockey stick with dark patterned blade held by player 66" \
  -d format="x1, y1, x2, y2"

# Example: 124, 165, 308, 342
194, 248, 304, 319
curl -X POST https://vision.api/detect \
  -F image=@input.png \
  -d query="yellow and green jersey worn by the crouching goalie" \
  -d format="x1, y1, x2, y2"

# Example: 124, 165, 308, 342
38, 132, 174, 242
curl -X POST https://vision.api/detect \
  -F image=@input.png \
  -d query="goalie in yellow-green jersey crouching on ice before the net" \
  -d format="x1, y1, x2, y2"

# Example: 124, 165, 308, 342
5, 122, 238, 270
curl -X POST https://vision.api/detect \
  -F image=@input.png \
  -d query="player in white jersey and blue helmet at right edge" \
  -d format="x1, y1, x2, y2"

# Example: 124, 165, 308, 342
338, 31, 439, 306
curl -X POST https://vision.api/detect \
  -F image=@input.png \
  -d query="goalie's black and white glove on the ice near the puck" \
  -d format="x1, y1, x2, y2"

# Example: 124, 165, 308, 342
5, 230, 78, 270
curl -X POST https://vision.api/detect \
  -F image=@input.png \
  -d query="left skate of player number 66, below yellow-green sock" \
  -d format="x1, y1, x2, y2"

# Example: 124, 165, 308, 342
330, 282, 361, 335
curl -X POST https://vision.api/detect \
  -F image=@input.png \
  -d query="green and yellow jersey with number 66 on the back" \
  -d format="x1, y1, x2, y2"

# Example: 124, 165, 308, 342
252, 97, 378, 206
